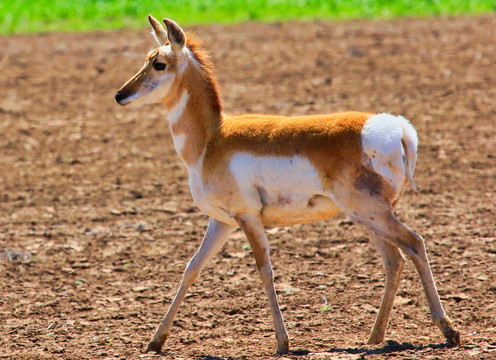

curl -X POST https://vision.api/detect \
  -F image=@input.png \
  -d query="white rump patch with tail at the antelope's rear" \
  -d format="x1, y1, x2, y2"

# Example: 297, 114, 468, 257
362, 114, 418, 189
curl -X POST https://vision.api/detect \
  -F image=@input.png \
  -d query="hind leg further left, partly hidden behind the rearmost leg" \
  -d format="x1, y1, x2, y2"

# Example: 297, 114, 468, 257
367, 232, 405, 344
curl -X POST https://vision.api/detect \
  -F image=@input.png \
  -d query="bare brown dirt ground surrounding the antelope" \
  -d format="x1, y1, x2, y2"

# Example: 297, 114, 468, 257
0, 14, 496, 360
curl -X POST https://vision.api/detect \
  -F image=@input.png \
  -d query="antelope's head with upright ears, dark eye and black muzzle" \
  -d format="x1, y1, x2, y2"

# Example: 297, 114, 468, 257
115, 15, 189, 106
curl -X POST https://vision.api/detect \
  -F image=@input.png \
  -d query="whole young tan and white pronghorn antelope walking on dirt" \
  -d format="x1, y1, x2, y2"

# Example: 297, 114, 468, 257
115, 16, 460, 353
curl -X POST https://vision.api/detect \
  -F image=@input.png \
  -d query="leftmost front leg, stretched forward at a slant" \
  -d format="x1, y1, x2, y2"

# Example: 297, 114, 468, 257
145, 218, 234, 354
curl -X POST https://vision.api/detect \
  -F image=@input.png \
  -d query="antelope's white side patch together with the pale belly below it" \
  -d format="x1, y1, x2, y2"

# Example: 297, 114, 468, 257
229, 153, 339, 226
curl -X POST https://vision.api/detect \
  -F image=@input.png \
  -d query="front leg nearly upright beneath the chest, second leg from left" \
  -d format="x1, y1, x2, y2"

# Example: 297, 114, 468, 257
236, 215, 289, 354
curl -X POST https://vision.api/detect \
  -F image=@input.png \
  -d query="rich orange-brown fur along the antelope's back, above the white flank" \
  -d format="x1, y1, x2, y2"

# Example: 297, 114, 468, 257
203, 112, 373, 179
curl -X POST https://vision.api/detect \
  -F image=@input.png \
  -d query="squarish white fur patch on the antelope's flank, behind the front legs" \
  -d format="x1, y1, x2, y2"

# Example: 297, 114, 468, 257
229, 153, 323, 209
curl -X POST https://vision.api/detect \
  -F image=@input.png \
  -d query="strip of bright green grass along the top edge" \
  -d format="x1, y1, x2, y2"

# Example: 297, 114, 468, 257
0, 0, 496, 34
